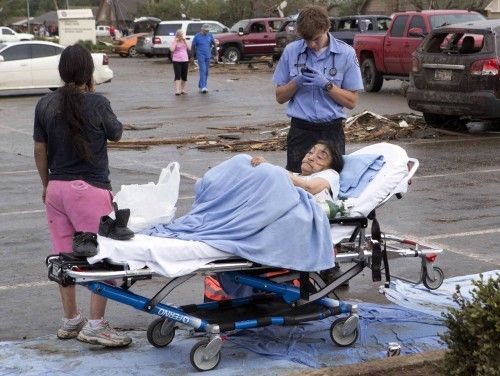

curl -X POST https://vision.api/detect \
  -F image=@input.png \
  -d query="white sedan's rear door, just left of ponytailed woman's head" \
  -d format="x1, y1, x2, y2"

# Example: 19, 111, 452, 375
31, 44, 63, 88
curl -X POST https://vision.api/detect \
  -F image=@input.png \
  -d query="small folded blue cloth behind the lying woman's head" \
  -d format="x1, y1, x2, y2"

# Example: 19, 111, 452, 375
339, 154, 385, 197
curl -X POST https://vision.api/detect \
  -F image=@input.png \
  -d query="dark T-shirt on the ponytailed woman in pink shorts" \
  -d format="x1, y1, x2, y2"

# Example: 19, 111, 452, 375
33, 91, 123, 189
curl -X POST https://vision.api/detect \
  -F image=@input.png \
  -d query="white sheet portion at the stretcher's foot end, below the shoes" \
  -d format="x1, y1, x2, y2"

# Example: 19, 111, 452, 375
88, 234, 234, 277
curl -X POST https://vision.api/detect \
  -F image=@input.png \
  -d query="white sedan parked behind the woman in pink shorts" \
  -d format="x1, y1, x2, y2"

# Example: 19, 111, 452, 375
0, 41, 113, 90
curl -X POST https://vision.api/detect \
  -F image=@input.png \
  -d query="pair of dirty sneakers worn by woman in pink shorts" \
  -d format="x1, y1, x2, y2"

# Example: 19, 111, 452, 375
57, 317, 132, 347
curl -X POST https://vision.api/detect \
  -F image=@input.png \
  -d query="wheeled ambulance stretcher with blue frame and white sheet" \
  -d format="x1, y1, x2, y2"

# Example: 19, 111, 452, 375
46, 144, 444, 371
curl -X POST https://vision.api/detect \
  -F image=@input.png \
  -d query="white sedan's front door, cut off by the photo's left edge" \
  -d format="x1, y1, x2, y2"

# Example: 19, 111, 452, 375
0, 43, 33, 90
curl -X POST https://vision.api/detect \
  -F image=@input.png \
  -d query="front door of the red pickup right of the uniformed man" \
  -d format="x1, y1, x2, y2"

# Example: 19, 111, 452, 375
384, 15, 409, 74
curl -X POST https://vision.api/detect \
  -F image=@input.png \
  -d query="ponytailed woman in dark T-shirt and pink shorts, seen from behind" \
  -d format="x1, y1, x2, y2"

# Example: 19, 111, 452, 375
33, 44, 132, 347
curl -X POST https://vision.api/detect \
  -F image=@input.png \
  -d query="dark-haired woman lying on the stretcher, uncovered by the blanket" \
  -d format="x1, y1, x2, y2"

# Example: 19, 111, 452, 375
250, 140, 344, 203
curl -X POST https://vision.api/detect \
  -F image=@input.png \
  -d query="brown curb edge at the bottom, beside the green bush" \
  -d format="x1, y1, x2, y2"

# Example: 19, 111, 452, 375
291, 350, 446, 376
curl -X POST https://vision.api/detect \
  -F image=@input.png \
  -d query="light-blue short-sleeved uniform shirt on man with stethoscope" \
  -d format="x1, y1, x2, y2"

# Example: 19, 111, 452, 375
273, 35, 363, 123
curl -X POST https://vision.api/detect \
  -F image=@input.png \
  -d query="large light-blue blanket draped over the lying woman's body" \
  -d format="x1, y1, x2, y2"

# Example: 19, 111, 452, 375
143, 154, 334, 271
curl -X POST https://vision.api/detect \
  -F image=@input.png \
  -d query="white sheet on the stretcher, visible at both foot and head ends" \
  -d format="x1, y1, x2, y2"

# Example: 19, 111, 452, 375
89, 143, 408, 277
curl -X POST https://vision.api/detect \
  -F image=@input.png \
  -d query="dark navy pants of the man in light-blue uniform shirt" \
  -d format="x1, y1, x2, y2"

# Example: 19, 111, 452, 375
286, 118, 345, 172
